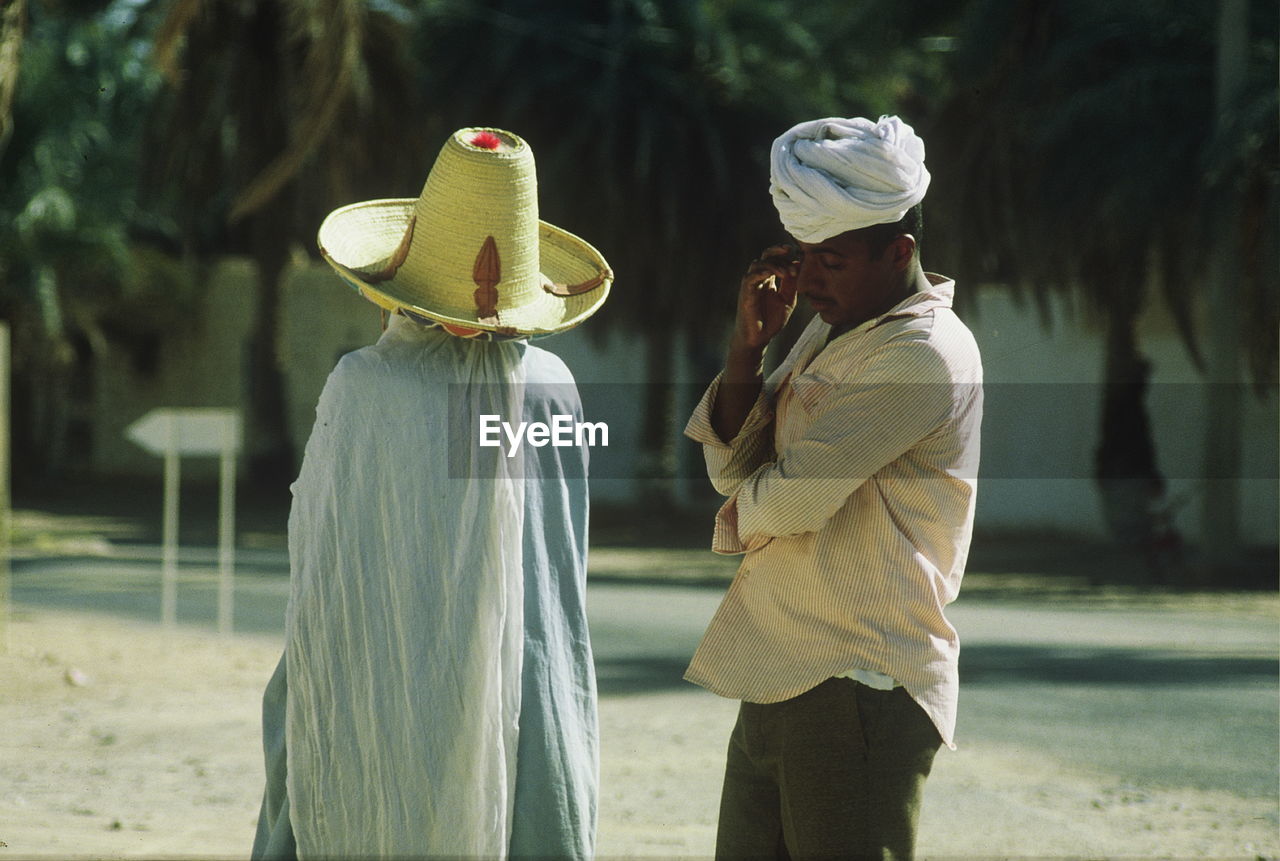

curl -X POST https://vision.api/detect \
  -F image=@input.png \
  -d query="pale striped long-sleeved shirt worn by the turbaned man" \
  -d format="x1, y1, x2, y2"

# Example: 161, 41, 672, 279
685, 275, 982, 747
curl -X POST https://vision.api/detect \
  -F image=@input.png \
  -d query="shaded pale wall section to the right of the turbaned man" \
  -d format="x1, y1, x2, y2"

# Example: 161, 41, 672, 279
964, 289, 1280, 544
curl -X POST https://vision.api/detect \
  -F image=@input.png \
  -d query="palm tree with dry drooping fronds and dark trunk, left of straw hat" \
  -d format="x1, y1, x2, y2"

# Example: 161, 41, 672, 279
148, 0, 424, 486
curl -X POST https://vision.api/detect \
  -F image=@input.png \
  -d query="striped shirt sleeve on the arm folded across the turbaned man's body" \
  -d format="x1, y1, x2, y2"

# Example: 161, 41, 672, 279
714, 342, 955, 553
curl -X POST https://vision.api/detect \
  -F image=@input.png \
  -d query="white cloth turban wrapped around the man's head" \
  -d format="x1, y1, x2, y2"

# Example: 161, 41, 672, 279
769, 116, 929, 242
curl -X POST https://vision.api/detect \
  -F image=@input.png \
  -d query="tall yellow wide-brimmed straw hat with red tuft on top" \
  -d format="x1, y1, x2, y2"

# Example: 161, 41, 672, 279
319, 128, 613, 339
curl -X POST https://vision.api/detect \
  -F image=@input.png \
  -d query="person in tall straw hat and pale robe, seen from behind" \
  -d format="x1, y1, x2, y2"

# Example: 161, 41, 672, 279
253, 129, 613, 858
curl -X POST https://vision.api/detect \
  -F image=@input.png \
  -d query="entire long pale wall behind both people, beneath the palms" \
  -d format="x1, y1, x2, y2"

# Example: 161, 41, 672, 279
95, 260, 1280, 544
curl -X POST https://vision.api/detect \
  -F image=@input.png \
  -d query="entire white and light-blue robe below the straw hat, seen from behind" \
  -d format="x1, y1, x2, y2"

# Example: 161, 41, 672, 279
255, 317, 598, 858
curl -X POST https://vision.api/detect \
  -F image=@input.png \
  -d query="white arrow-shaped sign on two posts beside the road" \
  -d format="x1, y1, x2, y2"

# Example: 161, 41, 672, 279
124, 408, 241, 635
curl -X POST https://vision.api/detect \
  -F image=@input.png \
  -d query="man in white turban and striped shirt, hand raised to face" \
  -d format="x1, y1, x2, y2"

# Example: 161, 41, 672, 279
686, 116, 982, 858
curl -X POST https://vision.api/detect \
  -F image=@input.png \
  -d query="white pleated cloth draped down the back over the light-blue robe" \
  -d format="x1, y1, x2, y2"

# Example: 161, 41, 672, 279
285, 317, 529, 858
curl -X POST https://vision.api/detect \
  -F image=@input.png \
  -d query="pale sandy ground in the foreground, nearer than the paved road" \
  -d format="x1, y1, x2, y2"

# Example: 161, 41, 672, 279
0, 608, 1280, 861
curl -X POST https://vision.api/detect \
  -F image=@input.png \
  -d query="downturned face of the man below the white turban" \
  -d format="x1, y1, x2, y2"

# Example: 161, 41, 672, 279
796, 232, 902, 330
